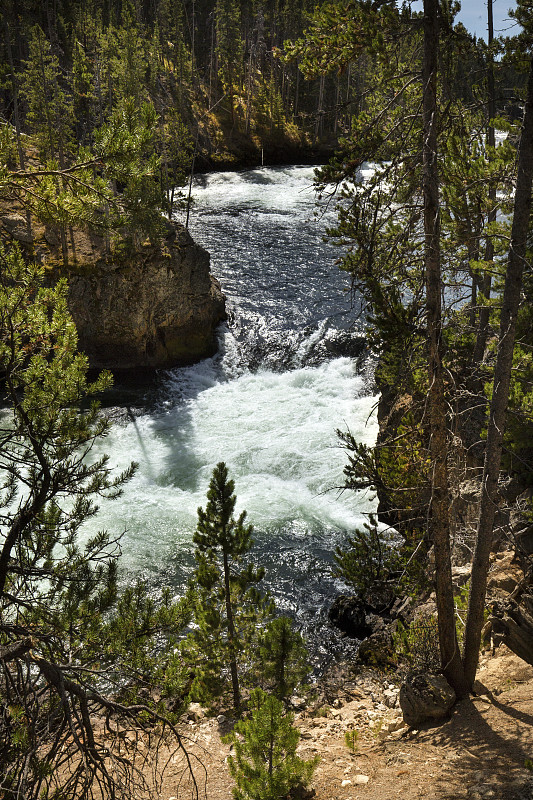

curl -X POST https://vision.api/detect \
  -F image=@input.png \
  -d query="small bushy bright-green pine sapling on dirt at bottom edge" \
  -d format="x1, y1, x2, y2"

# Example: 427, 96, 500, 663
223, 689, 318, 800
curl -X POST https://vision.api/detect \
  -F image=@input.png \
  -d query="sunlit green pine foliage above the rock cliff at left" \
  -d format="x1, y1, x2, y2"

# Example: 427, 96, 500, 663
0, 102, 168, 266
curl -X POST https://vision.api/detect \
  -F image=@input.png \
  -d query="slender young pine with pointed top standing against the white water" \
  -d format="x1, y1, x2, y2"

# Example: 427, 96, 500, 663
184, 462, 272, 710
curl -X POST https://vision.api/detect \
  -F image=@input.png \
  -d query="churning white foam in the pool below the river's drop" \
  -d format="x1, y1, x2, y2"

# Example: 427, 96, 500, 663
87, 358, 377, 584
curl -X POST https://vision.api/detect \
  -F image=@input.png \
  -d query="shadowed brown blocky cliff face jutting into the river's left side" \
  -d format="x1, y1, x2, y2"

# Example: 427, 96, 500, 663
69, 225, 225, 370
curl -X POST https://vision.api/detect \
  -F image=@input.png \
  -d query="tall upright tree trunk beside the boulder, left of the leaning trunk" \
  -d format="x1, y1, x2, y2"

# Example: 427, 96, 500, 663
423, 0, 465, 696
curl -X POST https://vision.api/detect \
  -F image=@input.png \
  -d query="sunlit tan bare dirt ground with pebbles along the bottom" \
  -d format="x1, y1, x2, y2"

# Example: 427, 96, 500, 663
160, 646, 533, 800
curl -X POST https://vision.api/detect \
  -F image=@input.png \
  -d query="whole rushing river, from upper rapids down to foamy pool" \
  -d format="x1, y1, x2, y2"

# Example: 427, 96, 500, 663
89, 167, 376, 665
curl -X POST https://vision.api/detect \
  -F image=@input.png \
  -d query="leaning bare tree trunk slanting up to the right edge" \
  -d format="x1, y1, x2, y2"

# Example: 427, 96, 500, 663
464, 51, 533, 686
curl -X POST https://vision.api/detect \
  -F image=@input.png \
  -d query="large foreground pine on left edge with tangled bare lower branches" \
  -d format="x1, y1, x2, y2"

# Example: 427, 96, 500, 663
0, 248, 187, 800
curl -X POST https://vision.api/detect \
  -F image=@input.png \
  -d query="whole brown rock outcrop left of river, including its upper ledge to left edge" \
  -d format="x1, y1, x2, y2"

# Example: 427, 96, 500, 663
0, 212, 225, 371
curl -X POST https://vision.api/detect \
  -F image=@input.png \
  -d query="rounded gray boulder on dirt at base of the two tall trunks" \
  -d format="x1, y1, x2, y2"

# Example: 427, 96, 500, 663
400, 672, 456, 728
